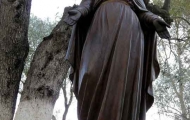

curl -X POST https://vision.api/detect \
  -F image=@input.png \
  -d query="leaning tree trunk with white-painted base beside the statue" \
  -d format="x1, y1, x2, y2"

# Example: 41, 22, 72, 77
15, 7, 71, 120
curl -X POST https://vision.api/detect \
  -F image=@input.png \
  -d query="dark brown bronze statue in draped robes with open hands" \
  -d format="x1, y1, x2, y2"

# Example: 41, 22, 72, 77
65, 0, 170, 120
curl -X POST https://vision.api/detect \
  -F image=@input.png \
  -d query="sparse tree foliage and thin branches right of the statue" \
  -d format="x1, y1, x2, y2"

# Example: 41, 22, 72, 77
154, 0, 190, 120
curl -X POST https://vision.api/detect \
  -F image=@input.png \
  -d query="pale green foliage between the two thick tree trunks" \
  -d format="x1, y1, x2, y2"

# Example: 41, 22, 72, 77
24, 15, 56, 75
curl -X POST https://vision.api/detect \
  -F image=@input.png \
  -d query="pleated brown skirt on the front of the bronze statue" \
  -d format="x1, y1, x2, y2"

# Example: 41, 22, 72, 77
78, 2, 144, 120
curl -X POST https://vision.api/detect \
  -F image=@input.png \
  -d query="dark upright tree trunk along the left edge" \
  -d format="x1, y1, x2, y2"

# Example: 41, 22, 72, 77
0, 0, 31, 120
